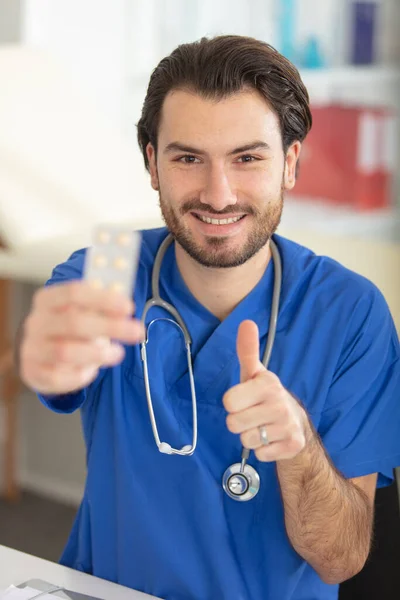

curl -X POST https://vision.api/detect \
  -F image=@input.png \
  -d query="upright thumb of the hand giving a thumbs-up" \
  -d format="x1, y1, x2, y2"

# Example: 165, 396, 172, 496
236, 321, 265, 383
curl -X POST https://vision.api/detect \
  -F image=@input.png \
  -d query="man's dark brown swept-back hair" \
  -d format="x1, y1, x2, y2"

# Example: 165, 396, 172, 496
137, 35, 312, 169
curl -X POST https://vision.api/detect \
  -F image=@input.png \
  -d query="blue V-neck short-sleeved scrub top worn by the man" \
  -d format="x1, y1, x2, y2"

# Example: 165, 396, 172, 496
41, 229, 400, 600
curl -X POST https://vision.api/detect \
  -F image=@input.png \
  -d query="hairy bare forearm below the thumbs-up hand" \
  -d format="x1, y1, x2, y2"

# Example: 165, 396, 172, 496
277, 414, 372, 583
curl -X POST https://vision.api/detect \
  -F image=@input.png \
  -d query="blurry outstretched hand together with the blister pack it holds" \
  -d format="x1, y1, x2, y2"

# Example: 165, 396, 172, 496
20, 227, 145, 395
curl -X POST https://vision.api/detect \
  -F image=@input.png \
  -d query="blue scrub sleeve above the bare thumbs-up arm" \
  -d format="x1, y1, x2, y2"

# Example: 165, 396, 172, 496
318, 284, 400, 487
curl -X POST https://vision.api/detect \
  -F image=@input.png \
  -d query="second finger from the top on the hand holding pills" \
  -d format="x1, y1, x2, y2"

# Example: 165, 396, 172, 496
26, 308, 145, 344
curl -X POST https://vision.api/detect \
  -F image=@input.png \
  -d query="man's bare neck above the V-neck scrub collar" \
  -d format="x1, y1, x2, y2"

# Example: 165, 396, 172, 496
175, 243, 271, 321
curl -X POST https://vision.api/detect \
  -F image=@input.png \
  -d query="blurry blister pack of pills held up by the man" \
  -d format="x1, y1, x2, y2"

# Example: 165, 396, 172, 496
84, 225, 141, 298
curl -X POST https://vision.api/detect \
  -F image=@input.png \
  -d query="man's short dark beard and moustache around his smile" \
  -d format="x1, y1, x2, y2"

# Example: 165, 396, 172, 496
159, 183, 284, 269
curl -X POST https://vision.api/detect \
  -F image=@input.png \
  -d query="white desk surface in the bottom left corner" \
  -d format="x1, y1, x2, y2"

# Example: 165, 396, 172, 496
0, 546, 159, 600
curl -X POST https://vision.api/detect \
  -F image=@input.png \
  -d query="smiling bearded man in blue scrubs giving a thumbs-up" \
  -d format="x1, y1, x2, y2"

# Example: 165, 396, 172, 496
20, 36, 400, 600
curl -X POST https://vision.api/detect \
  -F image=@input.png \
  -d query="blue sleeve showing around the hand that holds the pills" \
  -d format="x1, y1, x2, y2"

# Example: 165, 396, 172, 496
37, 250, 91, 413
